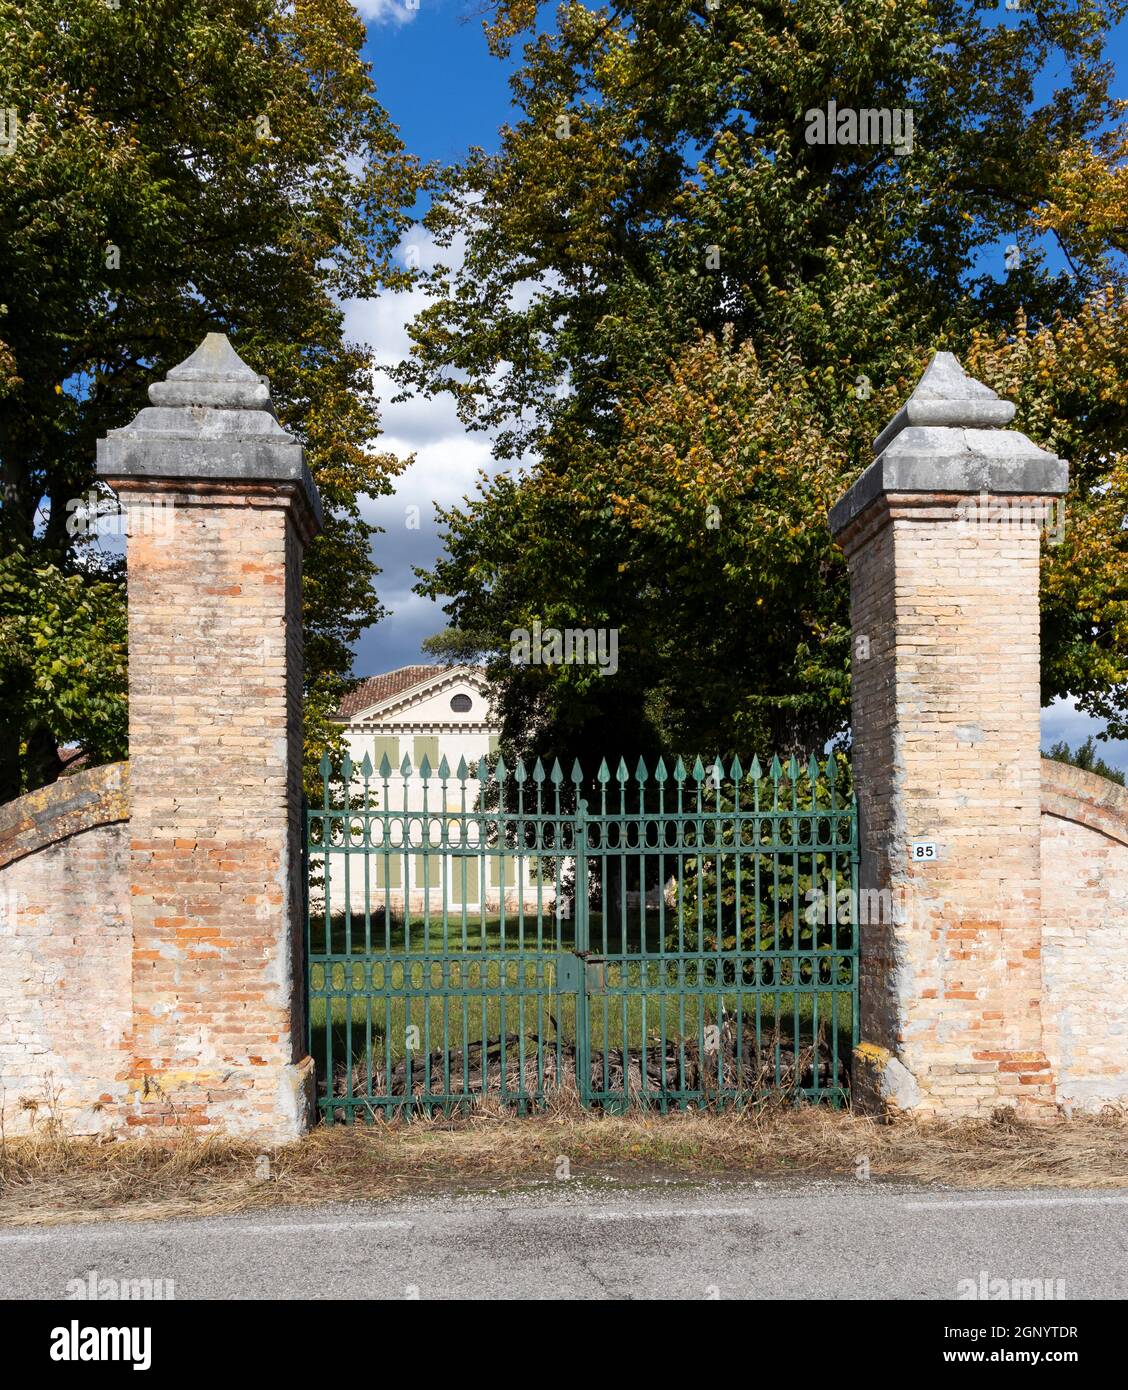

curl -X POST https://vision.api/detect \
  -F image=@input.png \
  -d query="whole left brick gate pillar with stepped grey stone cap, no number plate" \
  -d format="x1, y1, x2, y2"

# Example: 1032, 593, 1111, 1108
97, 334, 321, 1143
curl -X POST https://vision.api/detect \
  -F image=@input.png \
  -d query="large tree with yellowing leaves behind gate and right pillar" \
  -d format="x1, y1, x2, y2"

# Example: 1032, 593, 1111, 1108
401, 0, 1125, 756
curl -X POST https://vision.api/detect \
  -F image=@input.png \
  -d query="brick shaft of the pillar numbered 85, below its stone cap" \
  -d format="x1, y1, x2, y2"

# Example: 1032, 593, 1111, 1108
840, 493, 1053, 1113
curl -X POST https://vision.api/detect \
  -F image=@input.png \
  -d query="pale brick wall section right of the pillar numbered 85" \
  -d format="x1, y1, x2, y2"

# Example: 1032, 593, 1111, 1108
1042, 760, 1128, 1111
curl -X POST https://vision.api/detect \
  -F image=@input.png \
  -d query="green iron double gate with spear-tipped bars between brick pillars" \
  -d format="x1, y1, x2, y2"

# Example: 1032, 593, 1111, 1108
306, 756, 859, 1119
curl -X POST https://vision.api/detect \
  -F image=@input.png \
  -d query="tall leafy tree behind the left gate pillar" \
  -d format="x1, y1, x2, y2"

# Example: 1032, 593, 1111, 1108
0, 0, 421, 799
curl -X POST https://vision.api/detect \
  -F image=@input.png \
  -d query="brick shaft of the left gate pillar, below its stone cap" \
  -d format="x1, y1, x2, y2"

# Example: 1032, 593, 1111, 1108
122, 482, 311, 1136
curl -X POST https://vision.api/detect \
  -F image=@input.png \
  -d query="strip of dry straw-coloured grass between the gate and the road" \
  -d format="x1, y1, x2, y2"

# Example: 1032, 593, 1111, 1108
0, 1098, 1128, 1225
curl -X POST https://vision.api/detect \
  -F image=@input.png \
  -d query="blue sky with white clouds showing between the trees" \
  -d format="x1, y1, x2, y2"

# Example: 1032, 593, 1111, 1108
346, 0, 1128, 769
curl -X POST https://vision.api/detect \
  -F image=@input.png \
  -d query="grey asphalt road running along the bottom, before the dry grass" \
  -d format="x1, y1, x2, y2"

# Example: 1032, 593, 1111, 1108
0, 1183, 1128, 1300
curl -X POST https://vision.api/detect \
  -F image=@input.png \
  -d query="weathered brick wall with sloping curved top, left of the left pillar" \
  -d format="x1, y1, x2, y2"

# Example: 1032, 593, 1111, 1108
0, 763, 132, 1134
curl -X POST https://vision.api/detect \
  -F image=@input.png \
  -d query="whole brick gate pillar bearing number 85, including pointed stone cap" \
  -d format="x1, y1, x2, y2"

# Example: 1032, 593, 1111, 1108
831, 353, 1067, 1115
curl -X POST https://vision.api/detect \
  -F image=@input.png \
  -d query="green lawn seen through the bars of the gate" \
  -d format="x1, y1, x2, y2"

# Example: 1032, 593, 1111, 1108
310, 912, 852, 1094
